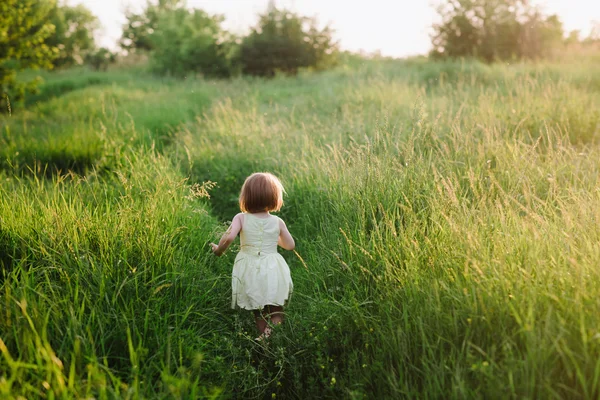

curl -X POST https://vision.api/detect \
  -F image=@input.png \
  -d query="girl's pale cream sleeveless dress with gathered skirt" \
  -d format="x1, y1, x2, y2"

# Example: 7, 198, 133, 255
231, 213, 294, 310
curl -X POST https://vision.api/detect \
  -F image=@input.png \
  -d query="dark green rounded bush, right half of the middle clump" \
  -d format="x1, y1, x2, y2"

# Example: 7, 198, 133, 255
239, 5, 337, 77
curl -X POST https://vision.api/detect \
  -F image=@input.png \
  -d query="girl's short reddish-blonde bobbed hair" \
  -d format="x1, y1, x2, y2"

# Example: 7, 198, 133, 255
240, 172, 283, 213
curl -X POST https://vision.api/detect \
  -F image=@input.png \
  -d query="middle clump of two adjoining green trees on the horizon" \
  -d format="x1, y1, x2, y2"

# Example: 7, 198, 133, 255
120, 0, 338, 77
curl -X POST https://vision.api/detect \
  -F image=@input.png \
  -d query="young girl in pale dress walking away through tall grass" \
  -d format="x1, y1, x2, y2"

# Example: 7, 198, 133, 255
211, 173, 295, 340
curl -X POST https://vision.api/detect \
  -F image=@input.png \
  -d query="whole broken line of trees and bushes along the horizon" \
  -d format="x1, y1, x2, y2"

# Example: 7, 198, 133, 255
0, 0, 600, 111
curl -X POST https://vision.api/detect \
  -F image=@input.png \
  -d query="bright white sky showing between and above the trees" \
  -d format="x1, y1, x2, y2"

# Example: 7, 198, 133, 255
68, 0, 600, 57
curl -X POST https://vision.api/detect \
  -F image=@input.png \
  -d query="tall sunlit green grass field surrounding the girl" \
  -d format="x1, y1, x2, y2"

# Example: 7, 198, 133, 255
0, 57, 600, 399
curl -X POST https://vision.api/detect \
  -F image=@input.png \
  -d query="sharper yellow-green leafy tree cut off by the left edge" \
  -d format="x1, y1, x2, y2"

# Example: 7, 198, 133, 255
0, 0, 56, 113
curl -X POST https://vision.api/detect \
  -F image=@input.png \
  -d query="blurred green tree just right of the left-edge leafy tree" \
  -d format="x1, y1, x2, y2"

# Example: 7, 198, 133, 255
45, 4, 100, 68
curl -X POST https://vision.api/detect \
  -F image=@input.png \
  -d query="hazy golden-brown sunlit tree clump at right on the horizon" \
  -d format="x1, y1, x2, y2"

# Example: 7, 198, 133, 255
432, 0, 563, 62
